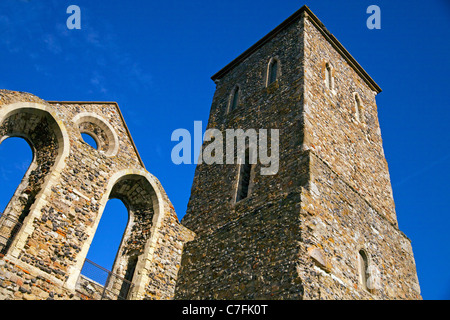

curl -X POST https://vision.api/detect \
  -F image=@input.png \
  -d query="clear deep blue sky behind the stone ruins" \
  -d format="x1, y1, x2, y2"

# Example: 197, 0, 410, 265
0, 0, 450, 299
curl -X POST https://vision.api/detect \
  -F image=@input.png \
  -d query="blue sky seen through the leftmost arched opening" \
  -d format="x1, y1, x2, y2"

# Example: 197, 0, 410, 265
0, 137, 33, 215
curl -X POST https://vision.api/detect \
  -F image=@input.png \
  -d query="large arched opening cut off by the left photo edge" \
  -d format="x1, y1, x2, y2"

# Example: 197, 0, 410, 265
0, 108, 64, 254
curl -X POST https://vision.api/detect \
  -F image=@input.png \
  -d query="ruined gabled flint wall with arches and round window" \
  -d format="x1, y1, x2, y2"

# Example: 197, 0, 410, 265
0, 90, 193, 300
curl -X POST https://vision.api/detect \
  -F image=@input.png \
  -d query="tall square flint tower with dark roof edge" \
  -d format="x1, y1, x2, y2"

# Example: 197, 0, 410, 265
175, 6, 421, 299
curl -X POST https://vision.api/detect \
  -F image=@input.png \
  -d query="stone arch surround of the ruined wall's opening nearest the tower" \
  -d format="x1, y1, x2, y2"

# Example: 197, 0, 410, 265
67, 169, 192, 300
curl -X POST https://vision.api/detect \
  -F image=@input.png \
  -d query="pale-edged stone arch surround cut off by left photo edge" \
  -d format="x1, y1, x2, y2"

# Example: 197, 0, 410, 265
0, 102, 68, 254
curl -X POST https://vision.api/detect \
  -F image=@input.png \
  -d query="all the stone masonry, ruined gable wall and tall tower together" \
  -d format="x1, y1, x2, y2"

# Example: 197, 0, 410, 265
0, 6, 421, 300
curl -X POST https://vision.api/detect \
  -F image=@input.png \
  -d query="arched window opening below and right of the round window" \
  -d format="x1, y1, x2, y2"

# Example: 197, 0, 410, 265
77, 174, 159, 299
